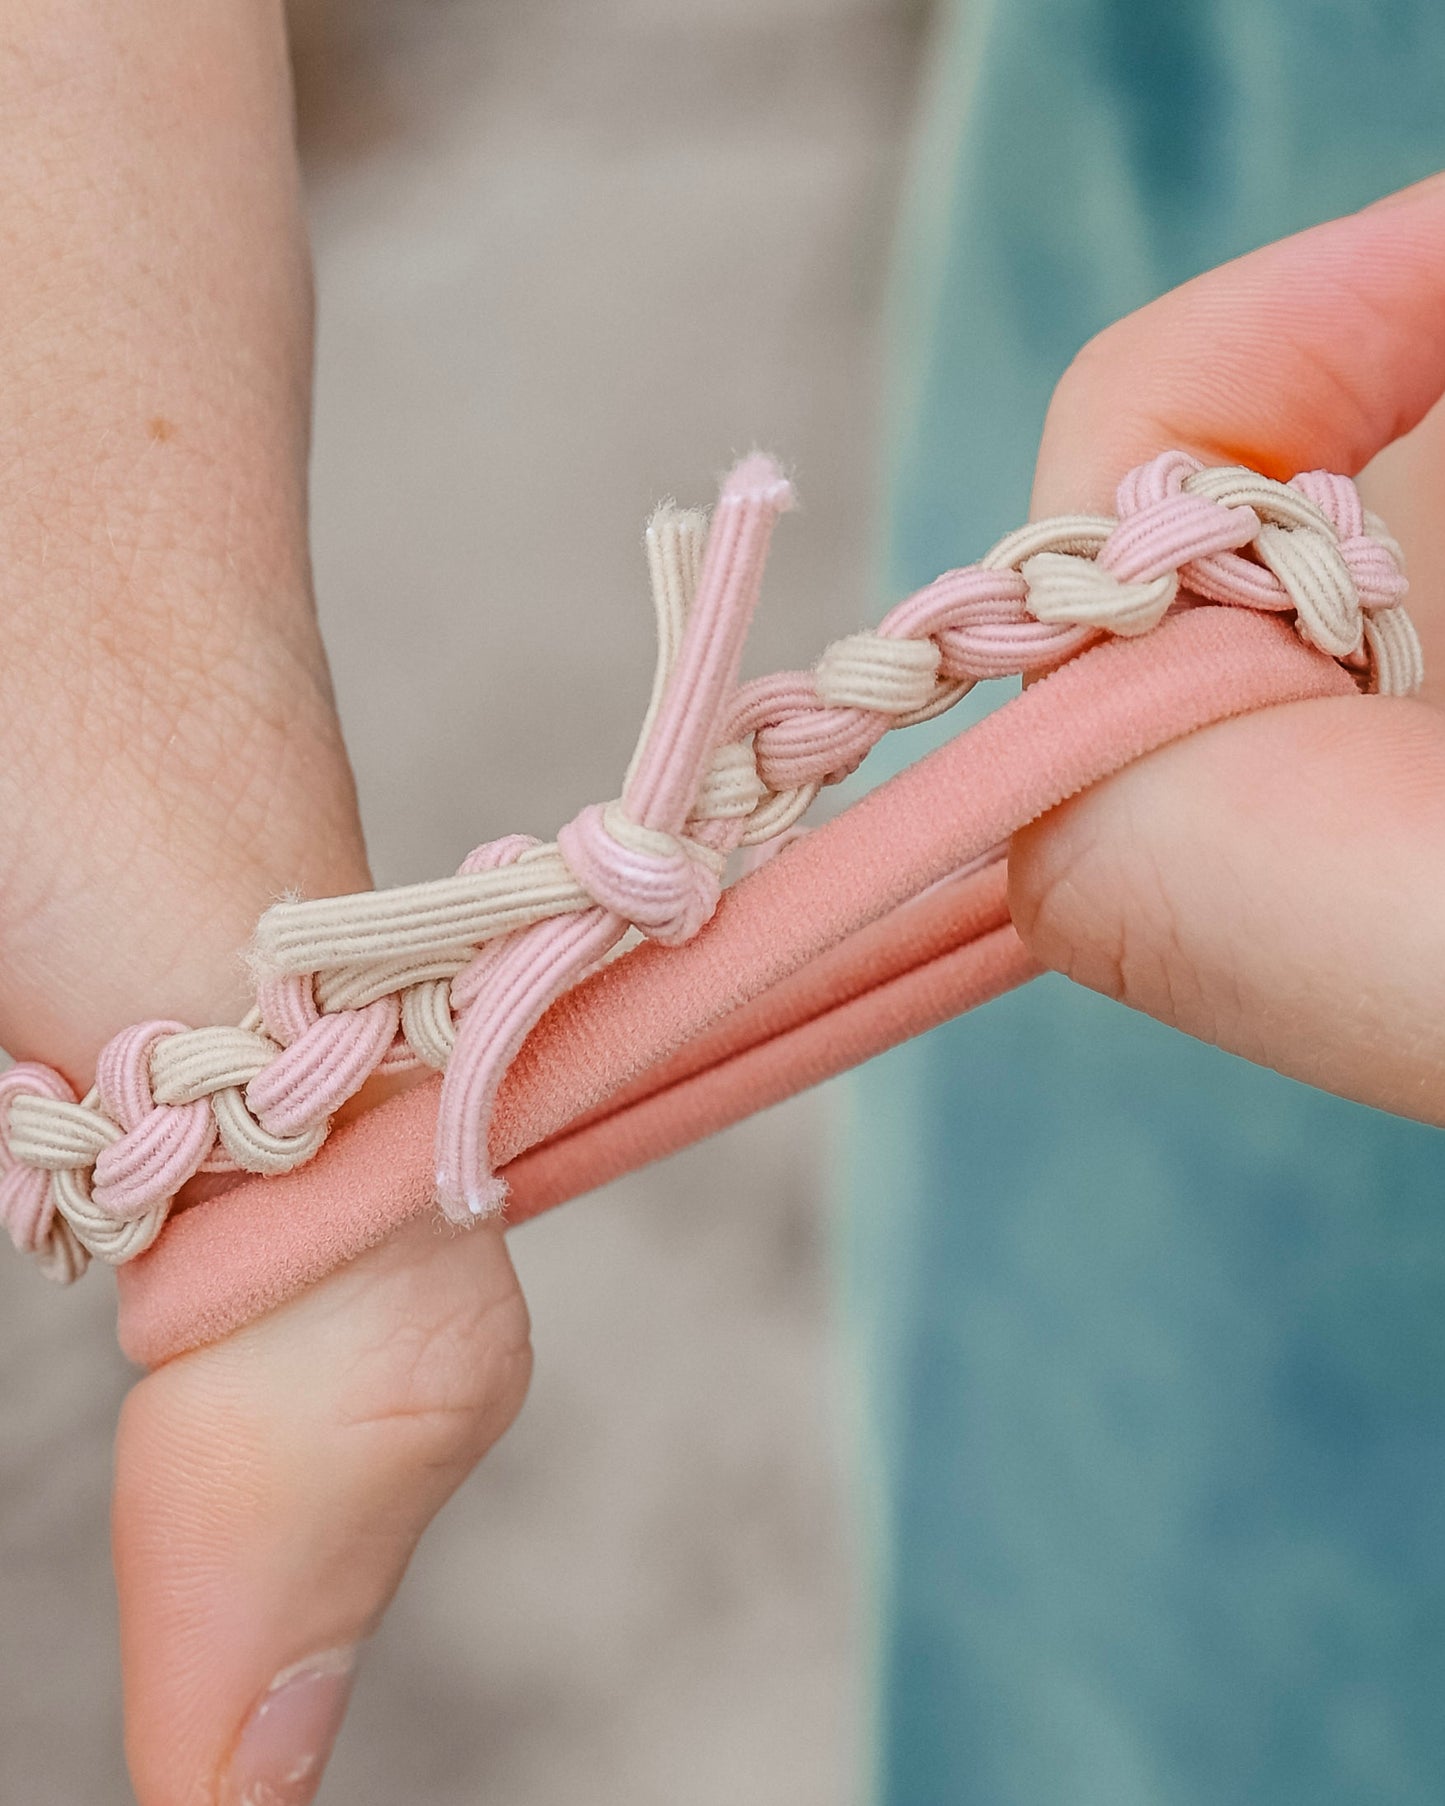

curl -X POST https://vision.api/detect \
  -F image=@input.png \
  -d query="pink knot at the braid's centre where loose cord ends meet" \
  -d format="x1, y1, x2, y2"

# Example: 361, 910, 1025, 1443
556, 802, 723, 946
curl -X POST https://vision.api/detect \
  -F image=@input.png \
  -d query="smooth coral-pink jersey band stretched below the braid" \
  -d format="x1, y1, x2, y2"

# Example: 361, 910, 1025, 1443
119, 607, 1369, 1365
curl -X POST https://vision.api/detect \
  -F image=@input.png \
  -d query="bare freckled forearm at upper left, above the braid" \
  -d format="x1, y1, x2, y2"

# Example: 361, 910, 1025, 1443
0, 0, 367, 1078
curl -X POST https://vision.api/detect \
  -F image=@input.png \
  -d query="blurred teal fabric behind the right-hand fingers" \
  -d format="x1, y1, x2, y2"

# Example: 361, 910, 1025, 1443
838, 0, 1445, 1806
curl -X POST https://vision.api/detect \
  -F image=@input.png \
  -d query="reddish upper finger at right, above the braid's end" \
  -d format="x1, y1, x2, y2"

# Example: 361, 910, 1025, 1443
1033, 173, 1445, 515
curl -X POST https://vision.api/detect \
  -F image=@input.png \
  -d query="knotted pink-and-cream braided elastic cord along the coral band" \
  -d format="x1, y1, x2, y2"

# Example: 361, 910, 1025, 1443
0, 452, 1422, 1282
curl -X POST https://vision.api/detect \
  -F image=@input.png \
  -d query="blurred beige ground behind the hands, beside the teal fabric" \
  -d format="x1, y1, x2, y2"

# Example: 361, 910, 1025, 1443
0, 0, 919, 1806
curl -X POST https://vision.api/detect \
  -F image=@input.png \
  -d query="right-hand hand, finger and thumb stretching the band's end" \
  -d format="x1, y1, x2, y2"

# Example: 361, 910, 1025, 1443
1010, 179, 1445, 1123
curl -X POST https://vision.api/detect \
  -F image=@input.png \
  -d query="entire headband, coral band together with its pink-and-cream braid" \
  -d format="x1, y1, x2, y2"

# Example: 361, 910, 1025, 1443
0, 452, 1420, 1362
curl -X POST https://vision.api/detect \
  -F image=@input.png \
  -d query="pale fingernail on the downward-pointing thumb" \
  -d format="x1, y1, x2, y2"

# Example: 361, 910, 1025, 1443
226, 1649, 356, 1806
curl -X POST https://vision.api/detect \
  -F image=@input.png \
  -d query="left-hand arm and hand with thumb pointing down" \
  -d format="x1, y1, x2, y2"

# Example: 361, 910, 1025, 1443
0, 0, 527, 1806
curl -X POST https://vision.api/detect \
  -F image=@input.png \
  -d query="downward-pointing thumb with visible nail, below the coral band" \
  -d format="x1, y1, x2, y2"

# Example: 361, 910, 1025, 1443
114, 1199, 529, 1806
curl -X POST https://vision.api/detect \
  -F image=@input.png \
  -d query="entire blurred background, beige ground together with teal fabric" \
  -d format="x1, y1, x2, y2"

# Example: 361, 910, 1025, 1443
11, 0, 1445, 1806
